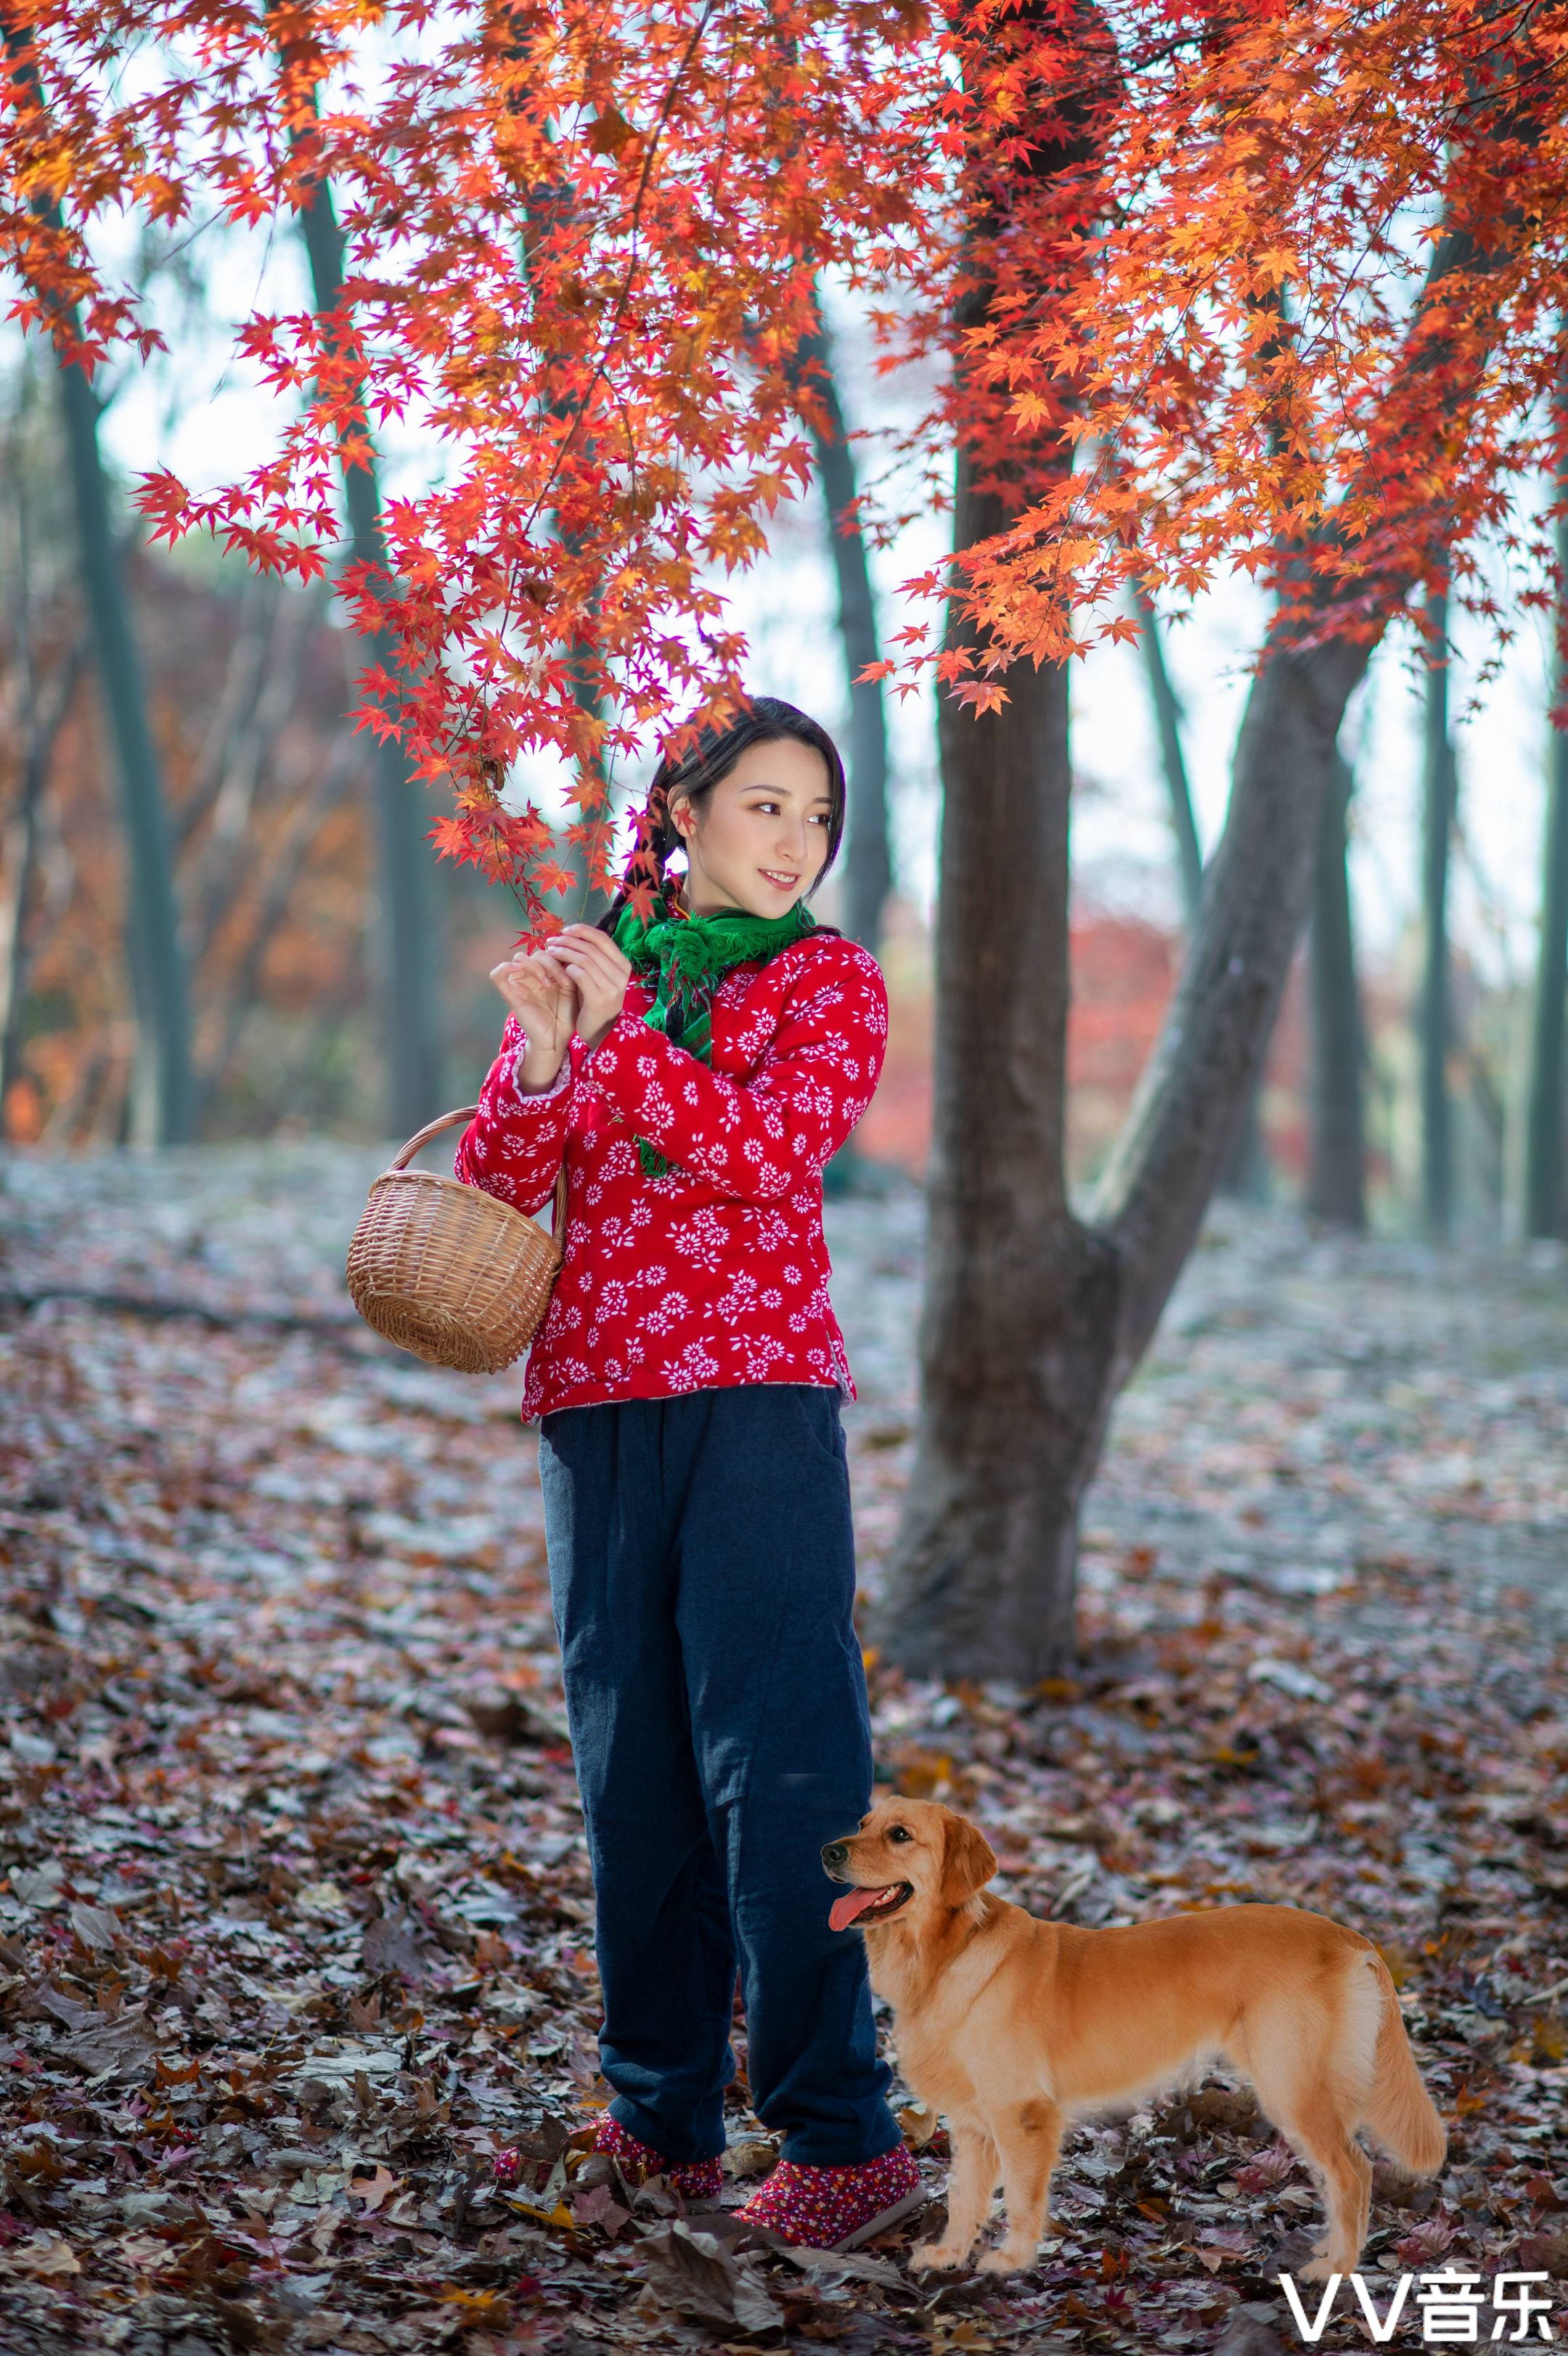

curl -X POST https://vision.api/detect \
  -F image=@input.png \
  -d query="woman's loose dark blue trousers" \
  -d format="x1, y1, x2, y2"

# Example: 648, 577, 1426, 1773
539, 1383, 899, 2167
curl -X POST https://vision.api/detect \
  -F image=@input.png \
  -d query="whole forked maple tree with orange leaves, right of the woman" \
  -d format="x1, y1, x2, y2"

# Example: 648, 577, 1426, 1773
871, 0, 1564, 1677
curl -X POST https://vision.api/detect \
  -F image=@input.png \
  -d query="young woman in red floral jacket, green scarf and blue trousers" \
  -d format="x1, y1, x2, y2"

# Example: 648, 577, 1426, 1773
457, 698, 920, 2248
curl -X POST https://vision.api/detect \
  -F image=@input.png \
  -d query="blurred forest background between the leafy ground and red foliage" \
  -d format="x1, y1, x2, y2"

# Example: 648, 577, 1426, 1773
0, 280, 1568, 1239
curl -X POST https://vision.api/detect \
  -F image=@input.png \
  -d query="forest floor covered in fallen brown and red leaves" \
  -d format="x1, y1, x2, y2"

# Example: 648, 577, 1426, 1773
0, 1143, 1568, 2356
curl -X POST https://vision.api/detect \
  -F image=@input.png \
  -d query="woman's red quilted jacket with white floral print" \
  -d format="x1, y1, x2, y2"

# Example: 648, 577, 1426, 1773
457, 926, 888, 1423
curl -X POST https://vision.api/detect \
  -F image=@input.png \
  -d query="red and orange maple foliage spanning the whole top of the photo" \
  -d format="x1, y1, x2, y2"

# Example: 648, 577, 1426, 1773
0, 0, 1568, 929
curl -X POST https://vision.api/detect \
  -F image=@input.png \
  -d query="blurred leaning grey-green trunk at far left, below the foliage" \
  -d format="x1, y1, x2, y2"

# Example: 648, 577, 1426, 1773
59, 351, 195, 1145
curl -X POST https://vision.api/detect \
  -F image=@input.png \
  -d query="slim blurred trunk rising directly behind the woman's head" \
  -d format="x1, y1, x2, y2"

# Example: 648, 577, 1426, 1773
796, 309, 892, 956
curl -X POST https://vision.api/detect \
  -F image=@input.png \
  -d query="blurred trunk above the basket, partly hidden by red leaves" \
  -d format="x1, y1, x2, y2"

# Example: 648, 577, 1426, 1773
299, 179, 440, 1136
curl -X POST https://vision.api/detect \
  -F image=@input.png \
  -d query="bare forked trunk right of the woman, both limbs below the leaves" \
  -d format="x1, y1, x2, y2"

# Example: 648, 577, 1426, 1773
873, 568, 1368, 1680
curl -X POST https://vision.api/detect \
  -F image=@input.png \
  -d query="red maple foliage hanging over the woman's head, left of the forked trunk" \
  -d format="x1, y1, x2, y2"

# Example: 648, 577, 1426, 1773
0, 0, 935, 919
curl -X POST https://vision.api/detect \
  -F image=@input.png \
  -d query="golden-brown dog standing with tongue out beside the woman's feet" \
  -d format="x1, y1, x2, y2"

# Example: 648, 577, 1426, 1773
822, 1800, 1448, 2280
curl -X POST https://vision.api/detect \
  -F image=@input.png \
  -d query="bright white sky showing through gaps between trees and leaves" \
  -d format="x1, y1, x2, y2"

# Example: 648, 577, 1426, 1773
79, 214, 1547, 1003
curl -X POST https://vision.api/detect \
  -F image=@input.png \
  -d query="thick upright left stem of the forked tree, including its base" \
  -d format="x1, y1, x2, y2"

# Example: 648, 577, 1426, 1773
881, 460, 1119, 1677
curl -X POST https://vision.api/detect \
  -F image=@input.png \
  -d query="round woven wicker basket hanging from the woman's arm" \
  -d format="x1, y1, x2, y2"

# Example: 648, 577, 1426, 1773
348, 1105, 565, 1374
